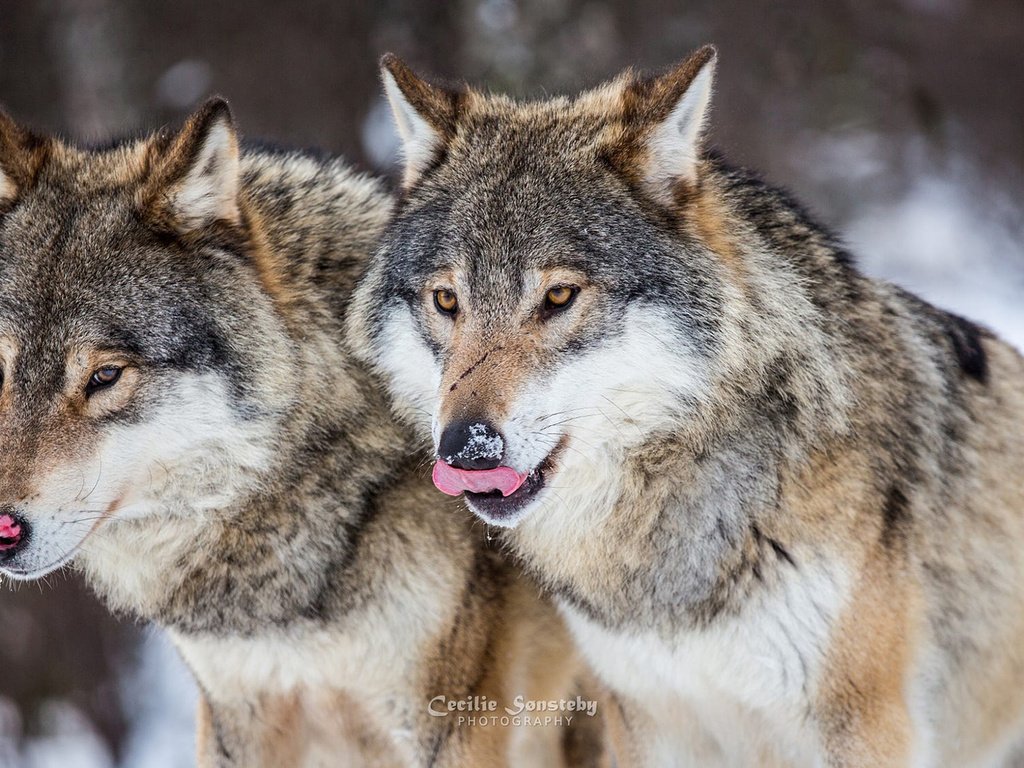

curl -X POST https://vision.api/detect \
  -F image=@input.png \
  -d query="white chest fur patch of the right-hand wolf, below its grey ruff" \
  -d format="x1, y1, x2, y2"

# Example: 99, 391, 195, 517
560, 560, 847, 767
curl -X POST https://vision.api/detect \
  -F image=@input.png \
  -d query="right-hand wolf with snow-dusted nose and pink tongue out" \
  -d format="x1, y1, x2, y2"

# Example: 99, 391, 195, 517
349, 47, 1024, 767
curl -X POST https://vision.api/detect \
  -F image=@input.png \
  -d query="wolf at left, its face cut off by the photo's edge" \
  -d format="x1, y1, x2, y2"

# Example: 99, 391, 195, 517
0, 98, 598, 768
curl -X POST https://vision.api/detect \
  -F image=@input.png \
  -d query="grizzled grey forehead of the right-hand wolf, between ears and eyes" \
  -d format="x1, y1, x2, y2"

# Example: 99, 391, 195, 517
384, 135, 688, 274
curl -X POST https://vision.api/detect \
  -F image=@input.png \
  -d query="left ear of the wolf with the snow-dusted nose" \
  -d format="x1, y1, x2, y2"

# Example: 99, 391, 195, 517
381, 53, 465, 187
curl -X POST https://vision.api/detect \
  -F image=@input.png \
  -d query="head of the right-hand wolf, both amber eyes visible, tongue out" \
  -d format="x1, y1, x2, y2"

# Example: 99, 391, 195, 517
353, 47, 745, 526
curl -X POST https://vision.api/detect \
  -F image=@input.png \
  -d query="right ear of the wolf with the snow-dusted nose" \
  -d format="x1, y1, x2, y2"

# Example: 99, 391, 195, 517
623, 45, 717, 204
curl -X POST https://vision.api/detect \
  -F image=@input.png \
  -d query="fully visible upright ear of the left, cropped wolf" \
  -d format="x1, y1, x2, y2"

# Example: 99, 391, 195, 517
141, 97, 242, 233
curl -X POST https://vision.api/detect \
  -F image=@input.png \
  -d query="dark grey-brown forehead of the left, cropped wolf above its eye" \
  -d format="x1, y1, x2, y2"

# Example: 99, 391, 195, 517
0, 152, 245, 367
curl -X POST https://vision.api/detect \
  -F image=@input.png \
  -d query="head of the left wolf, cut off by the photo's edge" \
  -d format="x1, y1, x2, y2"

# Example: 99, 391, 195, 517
0, 99, 288, 579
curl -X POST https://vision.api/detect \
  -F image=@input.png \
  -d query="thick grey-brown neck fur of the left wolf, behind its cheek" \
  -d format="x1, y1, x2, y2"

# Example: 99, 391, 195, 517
81, 153, 409, 634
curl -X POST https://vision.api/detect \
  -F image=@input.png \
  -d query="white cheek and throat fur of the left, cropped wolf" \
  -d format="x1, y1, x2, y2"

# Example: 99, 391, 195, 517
81, 374, 275, 605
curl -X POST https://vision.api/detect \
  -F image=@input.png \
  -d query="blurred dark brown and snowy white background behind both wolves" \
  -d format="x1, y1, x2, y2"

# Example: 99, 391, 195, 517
0, 0, 1024, 768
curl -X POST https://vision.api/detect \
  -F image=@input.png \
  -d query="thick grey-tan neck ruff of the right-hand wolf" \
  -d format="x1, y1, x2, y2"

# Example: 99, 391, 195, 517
508, 161, 970, 636
